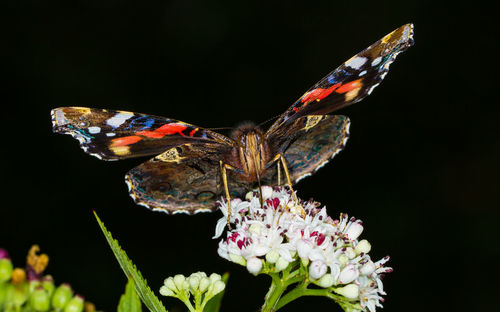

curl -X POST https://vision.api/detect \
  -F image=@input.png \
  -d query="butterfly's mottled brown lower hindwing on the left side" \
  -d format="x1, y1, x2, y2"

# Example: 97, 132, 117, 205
125, 143, 246, 214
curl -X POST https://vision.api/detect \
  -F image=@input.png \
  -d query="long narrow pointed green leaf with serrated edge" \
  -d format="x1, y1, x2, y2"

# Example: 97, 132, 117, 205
94, 211, 167, 312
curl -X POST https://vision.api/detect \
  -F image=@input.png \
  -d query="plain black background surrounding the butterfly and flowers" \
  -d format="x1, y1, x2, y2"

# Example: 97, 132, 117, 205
0, 0, 500, 311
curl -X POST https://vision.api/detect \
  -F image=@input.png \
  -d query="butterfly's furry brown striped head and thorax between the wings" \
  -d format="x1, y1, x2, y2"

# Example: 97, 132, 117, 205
227, 124, 272, 182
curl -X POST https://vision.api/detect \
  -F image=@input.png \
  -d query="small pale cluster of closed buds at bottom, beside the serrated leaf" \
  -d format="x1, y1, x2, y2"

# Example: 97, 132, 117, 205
160, 272, 226, 311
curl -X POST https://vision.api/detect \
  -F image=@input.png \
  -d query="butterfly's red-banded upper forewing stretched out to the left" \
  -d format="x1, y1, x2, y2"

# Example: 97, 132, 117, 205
51, 107, 233, 160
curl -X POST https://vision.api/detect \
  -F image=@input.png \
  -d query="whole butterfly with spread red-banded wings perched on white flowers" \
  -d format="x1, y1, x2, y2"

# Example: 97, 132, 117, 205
51, 24, 413, 214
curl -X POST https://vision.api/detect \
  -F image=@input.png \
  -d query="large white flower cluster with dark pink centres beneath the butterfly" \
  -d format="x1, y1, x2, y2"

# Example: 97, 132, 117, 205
215, 186, 392, 312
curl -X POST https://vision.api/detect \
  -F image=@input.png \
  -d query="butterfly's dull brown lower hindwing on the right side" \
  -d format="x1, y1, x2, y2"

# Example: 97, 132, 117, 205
264, 115, 350, 184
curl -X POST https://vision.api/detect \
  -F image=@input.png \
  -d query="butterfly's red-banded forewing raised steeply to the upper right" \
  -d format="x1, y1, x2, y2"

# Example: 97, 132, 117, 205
266, 24, 413, 137
